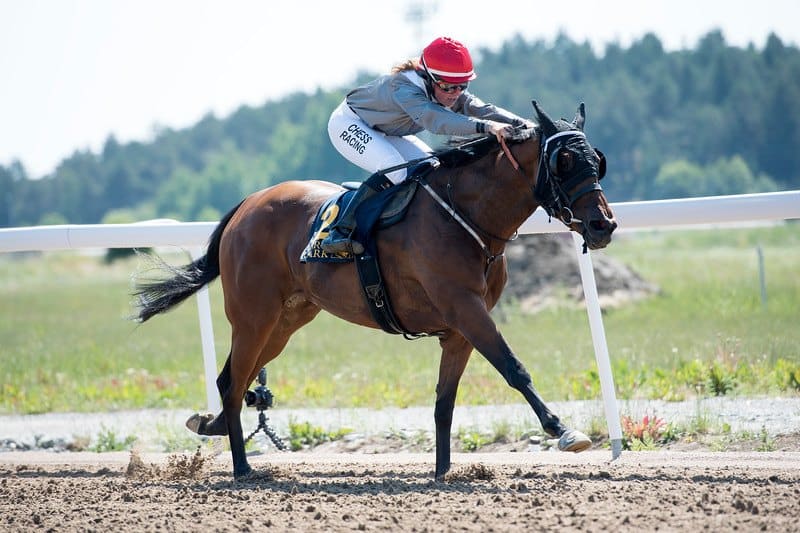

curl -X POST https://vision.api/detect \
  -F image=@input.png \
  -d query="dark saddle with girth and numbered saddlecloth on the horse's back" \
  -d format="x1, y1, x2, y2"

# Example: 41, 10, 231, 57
300, 178, 426, 339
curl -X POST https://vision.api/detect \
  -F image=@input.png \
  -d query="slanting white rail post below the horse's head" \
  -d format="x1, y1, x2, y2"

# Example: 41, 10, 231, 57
572, 232, 622, 461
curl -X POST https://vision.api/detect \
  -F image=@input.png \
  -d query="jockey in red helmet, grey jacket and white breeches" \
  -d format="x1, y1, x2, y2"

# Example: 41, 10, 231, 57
322, 37, 530, 254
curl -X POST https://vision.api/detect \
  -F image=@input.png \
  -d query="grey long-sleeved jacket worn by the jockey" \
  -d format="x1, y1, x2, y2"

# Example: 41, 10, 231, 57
346, 71, 527, 137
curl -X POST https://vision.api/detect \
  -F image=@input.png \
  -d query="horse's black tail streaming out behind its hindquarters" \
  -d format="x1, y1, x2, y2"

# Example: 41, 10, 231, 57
133, 202, 242, 322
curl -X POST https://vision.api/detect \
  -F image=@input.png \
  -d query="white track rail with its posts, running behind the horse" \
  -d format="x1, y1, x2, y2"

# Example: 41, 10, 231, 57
0, 191, 800, 458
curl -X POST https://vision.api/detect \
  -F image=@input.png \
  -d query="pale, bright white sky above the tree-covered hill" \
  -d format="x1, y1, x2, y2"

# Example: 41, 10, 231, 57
0, 0, 800, 177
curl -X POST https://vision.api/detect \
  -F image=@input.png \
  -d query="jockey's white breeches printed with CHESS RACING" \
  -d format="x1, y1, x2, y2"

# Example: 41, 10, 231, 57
328, 98, 433, 185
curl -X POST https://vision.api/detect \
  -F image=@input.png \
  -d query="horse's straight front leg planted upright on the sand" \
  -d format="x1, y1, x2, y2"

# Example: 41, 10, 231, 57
433, 333, 472, 481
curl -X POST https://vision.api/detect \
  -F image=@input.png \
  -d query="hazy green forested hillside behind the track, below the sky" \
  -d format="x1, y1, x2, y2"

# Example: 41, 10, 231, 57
0, 31, 800, 226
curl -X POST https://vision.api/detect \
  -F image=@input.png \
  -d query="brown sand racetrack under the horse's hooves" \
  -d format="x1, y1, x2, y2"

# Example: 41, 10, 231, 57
0, 450, 800, 531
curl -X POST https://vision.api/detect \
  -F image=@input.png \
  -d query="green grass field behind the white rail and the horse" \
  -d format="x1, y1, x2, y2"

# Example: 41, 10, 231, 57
0, 224, 800, 413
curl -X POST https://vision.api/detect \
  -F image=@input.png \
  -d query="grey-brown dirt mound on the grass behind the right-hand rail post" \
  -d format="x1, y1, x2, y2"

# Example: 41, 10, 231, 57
501, 233, 659, 313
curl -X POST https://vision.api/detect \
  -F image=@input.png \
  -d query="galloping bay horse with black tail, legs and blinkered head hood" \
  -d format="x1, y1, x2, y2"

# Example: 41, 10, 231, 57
134, 101, 617, 480
